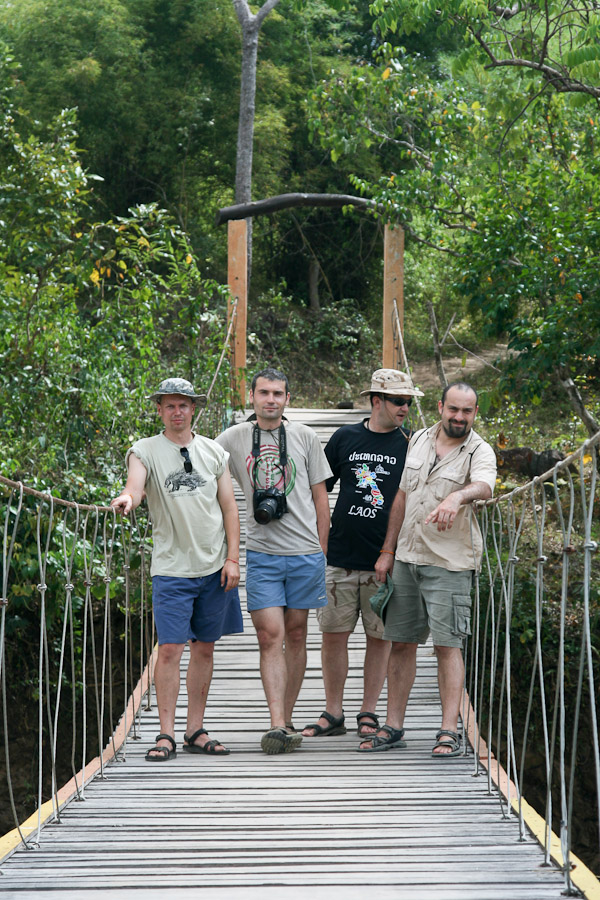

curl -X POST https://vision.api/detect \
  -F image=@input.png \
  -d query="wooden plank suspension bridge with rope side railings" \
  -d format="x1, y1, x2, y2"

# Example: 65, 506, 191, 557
0, 410, 600, 900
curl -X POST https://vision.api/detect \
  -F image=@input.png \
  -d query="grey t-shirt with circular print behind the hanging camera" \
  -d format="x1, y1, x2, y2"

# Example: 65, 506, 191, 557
216, 421, 332, 556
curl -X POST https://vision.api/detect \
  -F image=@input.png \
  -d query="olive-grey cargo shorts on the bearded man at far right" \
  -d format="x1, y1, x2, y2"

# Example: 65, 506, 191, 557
384, 560, 473, 647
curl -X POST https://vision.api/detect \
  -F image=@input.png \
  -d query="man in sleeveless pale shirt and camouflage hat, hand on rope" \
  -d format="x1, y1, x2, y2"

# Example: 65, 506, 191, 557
111, 378, 243, 762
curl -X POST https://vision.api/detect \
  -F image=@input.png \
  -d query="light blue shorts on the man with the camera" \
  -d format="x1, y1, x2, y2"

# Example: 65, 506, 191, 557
246, 550, 327, 612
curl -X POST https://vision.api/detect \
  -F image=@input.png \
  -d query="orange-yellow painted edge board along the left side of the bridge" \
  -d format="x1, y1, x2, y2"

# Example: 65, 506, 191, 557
0, 647, 158, 865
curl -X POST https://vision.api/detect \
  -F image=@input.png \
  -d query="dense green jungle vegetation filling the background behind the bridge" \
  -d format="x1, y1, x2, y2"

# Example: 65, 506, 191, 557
0, 0, 600, 876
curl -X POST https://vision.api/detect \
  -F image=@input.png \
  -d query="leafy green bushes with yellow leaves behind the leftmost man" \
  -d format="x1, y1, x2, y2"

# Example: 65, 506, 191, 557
0, 50, 234, 488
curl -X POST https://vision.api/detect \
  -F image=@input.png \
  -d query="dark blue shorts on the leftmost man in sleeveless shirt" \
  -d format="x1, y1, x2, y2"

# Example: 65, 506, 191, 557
152, 570, 244, 644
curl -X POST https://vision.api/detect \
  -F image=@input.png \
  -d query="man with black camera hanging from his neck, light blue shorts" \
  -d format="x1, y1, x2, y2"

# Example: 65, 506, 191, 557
217, 368, 332, 754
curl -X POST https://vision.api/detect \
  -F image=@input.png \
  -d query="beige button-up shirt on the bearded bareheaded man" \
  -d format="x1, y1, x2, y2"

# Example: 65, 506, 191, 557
396, 422, 496, 572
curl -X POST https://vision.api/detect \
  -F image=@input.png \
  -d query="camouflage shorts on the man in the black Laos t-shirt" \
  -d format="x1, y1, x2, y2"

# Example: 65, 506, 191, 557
317, 566, 383, 639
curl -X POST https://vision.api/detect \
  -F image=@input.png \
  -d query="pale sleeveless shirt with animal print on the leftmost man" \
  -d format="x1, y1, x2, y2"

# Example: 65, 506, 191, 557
127, 434, 227, 578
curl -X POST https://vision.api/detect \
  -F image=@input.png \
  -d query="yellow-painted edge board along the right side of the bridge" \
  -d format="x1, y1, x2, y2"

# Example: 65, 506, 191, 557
462, 691, 600, 900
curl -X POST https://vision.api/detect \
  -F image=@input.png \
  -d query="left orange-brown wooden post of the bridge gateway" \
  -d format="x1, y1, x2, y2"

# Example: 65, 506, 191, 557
227, 219, 248, 409
